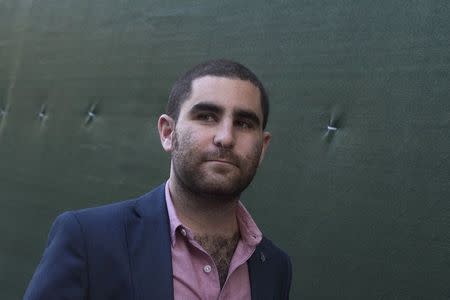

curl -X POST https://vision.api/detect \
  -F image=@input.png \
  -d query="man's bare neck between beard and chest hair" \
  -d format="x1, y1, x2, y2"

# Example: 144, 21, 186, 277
169, 174, 239, 237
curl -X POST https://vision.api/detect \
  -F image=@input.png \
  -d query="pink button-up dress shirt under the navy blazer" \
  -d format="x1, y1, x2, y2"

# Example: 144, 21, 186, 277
165, 181, 262, 300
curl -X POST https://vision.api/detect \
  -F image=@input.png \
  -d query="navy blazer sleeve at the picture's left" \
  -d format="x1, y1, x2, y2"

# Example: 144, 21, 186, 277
23, 212, 88, 300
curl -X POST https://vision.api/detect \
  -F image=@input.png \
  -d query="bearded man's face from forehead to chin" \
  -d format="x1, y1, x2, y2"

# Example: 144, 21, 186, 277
161, 76, 270, 197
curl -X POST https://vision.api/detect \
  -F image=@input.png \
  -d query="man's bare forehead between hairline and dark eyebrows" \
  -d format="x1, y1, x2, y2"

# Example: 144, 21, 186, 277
181, 76, 262, 119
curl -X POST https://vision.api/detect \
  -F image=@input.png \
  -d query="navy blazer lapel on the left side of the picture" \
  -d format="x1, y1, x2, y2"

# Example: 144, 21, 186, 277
126, 185, 173, 300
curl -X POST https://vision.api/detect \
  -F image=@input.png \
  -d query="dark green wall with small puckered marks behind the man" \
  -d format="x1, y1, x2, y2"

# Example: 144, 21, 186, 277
0, 0, 450, 299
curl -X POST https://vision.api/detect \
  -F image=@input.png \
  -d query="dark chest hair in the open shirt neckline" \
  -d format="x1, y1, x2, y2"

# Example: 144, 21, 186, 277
195, 232, 240, 288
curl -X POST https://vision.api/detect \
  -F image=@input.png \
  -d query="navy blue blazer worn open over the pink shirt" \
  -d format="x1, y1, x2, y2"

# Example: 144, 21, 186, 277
24, 185, 292, 300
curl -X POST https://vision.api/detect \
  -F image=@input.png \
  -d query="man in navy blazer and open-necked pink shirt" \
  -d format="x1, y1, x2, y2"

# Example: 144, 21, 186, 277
24, 60, 291, 300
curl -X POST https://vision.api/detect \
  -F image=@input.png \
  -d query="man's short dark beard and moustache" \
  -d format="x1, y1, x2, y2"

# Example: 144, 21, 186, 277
172, 130, 262, 199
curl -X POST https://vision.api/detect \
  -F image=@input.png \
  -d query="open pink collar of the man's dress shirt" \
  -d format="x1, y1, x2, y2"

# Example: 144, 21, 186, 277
165, 180, 262, 247
